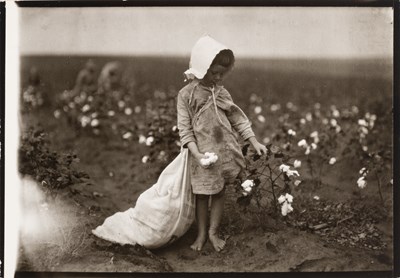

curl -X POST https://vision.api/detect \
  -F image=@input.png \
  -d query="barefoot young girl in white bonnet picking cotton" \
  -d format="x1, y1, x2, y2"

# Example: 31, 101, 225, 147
177, 36, 266, 252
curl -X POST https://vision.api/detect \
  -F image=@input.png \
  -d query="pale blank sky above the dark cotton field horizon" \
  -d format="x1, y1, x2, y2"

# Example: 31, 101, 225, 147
18, 7, 393, 58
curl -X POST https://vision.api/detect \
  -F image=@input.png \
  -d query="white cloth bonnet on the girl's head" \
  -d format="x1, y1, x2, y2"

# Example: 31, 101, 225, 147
184, 35, 228, 79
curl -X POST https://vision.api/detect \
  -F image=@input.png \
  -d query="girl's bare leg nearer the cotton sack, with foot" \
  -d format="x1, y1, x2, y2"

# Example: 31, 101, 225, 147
190, 194, 210, 251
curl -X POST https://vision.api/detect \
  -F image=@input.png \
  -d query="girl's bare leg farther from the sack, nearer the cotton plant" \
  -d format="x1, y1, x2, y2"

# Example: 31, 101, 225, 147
208, 189, 226, 252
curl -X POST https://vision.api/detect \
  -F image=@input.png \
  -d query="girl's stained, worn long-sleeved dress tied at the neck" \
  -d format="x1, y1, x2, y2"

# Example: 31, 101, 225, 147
177, 80, 254, 195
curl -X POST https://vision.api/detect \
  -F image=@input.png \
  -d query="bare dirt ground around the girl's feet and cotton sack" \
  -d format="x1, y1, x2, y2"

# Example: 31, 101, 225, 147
18, 107, 393, 272
